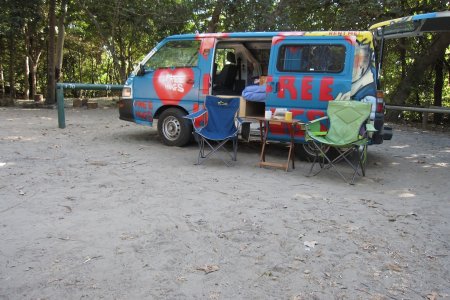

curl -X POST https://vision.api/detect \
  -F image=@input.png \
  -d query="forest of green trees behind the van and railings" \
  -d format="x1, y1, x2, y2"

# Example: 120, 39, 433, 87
0, 0, 450, 123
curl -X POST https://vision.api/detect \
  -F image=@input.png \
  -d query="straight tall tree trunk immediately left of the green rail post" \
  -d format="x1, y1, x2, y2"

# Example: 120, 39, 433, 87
45, 0, 56, 104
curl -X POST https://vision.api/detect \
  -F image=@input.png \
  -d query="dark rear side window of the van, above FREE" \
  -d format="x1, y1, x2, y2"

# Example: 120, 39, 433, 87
277, 45, 345, 73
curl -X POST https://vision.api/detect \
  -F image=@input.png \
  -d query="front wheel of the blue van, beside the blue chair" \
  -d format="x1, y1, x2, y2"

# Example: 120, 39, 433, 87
158, 108, 192, 147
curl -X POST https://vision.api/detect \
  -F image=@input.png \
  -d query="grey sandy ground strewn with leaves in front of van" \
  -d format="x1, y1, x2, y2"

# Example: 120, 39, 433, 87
0, 108, 450, 299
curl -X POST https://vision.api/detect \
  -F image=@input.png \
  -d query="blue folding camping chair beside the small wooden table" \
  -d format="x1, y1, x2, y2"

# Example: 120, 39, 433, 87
184, 96, 242, 166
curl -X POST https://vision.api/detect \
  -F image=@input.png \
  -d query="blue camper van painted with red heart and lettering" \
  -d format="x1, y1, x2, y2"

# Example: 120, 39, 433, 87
119, 14, 448, 154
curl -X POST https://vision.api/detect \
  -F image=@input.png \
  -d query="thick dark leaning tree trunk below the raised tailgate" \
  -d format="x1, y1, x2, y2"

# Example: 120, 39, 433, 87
389, 34, 450, 105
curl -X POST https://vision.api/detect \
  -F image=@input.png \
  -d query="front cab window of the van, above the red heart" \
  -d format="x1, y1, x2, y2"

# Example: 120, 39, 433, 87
145, 41, 200, 70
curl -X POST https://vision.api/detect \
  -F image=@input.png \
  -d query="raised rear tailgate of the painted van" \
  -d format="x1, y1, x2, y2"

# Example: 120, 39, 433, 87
369, 11, 450, 39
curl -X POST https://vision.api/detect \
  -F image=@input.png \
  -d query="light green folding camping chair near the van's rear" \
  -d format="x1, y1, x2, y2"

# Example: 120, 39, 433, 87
306, 101, 376, 184
